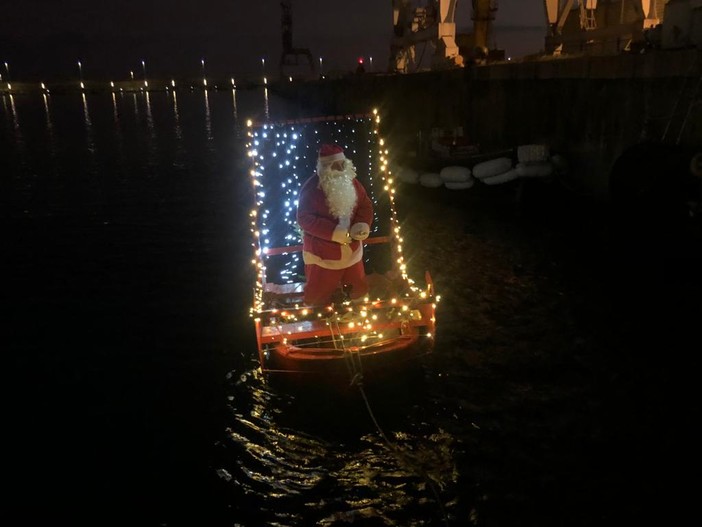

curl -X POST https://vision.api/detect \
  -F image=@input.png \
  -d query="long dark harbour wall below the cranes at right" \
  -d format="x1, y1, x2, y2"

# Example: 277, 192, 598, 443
271, 49, 702, 200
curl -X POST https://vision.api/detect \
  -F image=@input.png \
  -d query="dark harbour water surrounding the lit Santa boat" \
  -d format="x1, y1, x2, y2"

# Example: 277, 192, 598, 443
0, 91, 702, 527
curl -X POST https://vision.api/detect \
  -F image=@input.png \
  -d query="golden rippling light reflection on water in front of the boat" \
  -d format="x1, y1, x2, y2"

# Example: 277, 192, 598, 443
217, 370, 457, 526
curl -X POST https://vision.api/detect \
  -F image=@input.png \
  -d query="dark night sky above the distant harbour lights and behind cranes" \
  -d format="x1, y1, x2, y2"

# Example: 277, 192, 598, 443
0, 0, 545, 81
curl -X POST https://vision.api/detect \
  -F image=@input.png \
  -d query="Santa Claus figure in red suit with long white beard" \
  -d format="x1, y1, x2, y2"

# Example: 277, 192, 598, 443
297, 145, 373, 305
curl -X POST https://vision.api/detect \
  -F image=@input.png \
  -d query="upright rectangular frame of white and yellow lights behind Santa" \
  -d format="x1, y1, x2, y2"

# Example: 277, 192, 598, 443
246, 110, 428, 320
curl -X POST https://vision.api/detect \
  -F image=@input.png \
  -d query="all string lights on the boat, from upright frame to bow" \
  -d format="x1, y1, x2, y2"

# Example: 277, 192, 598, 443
246, 110, 439, 358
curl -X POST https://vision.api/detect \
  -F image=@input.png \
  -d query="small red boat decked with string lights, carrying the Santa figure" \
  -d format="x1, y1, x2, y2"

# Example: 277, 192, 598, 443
247, 111, 439, 385
